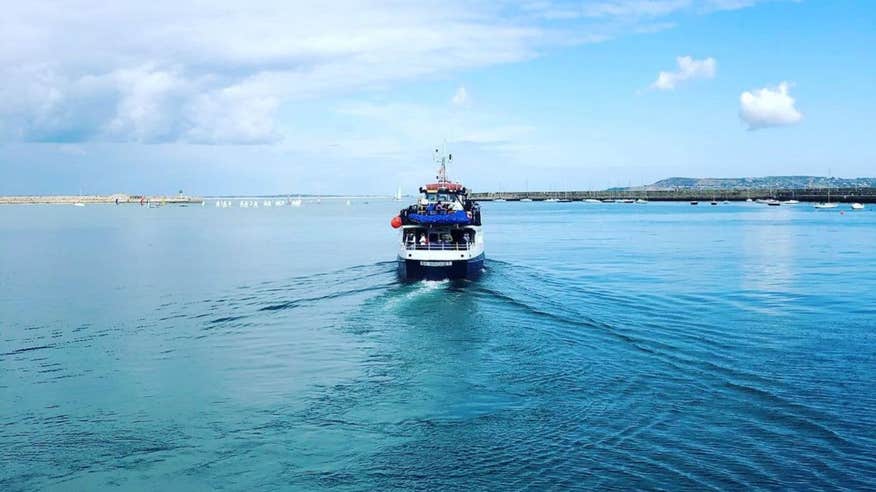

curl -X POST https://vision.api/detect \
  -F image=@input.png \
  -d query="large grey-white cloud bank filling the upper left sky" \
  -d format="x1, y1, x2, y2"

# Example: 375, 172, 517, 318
0, 0, 772, 144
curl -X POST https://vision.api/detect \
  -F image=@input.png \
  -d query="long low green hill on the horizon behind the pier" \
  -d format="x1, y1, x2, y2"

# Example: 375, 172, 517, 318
614, 176, 876, 191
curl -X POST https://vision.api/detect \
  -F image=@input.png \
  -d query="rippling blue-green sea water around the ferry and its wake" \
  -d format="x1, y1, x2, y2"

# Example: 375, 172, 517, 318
0, 201, 876, 491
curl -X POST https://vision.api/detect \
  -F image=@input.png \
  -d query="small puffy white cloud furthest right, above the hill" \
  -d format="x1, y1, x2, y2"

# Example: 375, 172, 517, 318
739, 82, 803, 130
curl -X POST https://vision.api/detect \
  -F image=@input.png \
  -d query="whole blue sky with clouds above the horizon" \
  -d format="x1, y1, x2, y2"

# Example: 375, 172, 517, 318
0, 0, 876, 195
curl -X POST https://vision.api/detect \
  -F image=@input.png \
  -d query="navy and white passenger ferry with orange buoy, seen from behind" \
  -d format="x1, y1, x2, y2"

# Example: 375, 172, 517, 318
390, 149, 486, 280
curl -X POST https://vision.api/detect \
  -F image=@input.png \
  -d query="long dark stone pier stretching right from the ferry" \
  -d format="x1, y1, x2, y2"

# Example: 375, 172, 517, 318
471, 188, 876, 203
